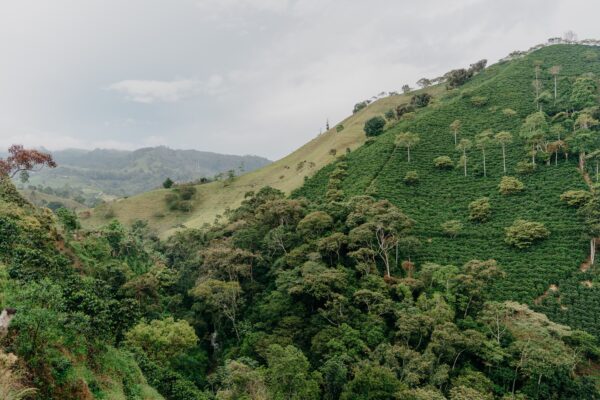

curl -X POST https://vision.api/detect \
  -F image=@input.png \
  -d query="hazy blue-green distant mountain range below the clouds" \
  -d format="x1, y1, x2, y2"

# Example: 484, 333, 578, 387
19, 146, 271, 197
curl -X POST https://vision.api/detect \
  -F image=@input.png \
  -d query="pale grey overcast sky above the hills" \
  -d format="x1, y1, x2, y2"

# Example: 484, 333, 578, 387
0, 0, 600, 160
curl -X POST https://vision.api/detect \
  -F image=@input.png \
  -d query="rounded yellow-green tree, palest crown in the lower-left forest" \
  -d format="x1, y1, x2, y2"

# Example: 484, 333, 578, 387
125, 317, 198, 362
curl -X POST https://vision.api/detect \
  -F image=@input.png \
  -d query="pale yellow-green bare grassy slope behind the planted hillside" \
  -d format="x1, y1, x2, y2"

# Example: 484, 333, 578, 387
83, 88, 440, 236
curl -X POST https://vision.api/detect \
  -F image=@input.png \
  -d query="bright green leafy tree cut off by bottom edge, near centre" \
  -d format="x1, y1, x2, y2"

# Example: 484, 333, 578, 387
266, 344, 321, 400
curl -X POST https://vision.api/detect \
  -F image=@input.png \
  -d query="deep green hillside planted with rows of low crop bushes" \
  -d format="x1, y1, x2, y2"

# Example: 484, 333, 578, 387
296, 46, 600, 334
